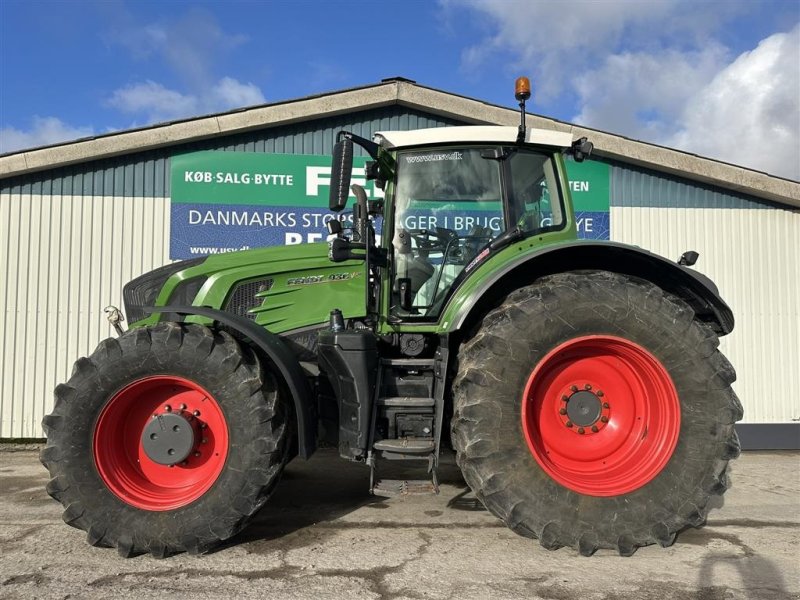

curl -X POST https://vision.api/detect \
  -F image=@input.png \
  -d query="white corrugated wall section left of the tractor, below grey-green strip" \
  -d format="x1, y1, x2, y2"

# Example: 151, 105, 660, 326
0, 193, 169, 438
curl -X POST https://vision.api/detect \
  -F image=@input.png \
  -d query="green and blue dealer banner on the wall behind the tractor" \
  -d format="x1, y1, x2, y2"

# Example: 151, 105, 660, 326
170, 152, 609, 259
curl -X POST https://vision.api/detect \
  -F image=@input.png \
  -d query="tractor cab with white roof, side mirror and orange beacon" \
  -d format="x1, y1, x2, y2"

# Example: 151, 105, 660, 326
330, 78, 592, 322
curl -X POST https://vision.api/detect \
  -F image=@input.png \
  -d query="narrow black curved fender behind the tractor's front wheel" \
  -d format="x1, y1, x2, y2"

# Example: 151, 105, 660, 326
144, 306, 317, 458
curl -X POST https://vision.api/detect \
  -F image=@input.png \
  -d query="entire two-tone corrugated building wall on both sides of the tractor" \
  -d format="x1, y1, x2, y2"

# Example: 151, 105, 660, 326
0, 106, 800, 438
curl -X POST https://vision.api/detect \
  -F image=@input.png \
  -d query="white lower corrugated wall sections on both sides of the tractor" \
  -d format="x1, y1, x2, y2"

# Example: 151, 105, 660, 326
0, 193, 800, 438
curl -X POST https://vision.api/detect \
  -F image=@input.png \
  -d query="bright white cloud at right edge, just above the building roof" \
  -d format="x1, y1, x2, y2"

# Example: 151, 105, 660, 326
665, 25, 800, 181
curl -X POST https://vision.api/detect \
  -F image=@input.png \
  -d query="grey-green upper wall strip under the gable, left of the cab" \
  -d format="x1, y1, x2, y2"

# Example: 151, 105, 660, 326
0, 105, 463, 198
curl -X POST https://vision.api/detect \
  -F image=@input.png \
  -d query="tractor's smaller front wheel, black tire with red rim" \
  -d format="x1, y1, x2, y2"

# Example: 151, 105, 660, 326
41, 323, 287, 557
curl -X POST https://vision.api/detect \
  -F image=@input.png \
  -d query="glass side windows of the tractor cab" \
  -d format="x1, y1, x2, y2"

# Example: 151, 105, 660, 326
391, 146, 564, 320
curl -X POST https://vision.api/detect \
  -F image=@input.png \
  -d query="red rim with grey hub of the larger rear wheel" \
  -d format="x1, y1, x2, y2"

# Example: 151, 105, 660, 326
522, 335, 681, 496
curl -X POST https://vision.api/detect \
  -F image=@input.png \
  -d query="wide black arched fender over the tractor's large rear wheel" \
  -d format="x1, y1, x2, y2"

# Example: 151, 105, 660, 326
452, 241, 734, 335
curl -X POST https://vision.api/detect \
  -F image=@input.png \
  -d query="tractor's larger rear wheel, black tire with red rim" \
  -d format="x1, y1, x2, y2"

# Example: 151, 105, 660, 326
452, 271, 742, 556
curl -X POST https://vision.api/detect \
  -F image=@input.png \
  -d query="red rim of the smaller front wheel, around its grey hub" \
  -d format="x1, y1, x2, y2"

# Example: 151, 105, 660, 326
93, 375, 228, 511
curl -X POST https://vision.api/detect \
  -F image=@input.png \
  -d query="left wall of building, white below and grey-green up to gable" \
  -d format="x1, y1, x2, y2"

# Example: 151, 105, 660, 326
0, 106, 459, 438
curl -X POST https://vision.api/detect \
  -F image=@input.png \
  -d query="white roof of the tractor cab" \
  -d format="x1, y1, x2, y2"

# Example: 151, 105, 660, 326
374, 125, 572, 148
